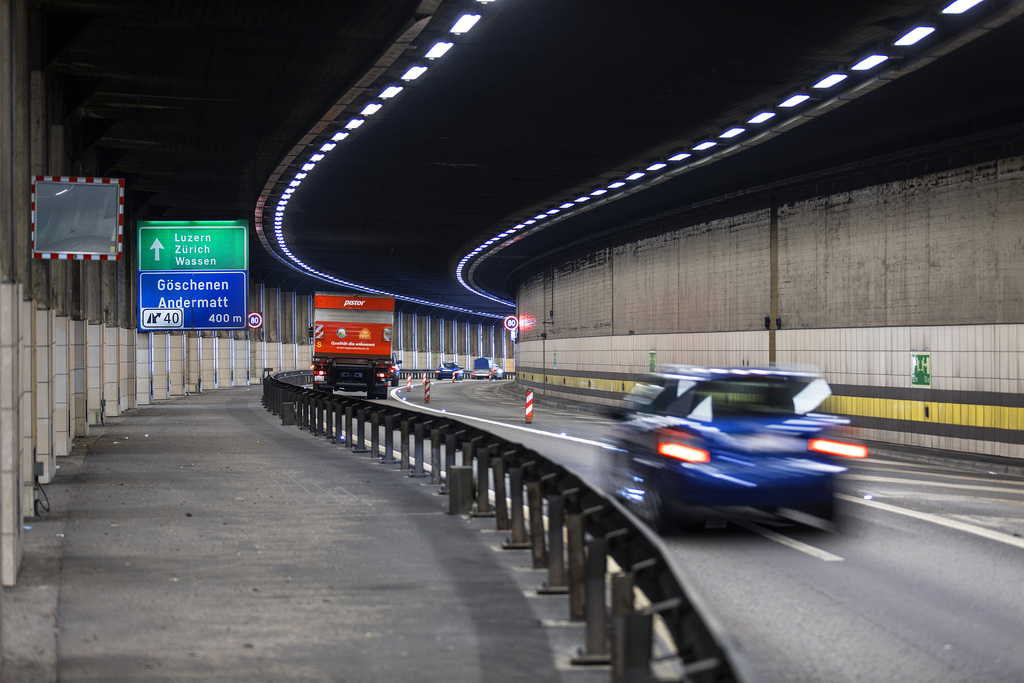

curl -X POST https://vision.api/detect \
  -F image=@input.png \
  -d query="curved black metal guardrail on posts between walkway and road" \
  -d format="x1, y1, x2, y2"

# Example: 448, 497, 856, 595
263, 373, 751, 683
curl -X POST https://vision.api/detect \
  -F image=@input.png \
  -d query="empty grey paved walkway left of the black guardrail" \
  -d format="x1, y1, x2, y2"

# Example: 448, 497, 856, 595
0, 387, 608, 683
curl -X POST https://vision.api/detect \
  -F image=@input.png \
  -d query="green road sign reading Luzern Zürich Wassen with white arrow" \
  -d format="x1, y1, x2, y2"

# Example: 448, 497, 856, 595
137, 220, 249, 271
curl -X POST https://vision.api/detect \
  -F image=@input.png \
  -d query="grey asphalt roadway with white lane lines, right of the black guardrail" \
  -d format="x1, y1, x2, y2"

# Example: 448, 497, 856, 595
390, 381, 1024, 682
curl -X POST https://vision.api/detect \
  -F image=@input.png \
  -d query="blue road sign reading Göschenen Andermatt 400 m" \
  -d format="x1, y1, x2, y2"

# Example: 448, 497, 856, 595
138, 270, 249, 332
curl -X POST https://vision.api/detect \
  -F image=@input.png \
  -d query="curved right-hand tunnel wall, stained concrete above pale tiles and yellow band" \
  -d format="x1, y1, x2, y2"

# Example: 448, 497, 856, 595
516, 152, 1024, 458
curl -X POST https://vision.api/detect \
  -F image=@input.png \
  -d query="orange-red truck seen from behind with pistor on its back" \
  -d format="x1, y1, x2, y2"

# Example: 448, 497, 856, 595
309, 292, 398, 398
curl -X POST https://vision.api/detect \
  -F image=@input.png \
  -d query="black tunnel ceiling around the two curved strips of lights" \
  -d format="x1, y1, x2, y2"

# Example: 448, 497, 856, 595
46, 0, 1024, 314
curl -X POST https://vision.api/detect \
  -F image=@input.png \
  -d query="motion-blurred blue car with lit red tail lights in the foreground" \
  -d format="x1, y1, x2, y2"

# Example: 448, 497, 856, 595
605, 366, 867, 531
